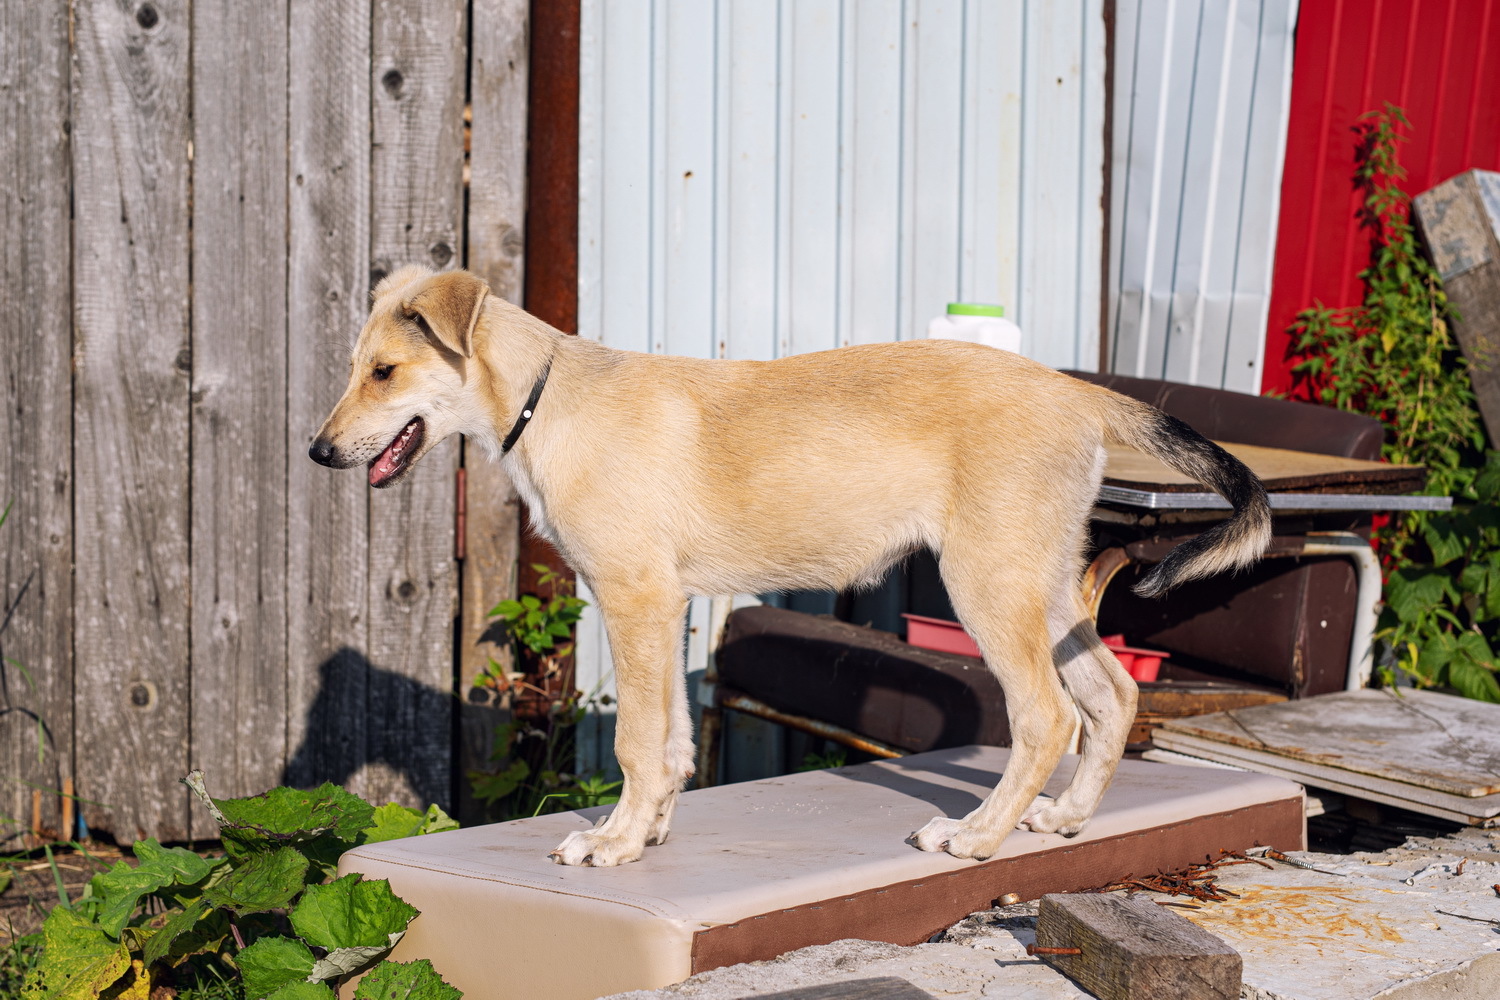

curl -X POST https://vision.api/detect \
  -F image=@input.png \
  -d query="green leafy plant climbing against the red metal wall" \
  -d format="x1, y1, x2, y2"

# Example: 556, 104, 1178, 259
1292, 103, 1500, 702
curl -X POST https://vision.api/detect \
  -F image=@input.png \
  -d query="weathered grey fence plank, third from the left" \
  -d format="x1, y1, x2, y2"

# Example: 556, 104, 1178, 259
191, 0, 289, 840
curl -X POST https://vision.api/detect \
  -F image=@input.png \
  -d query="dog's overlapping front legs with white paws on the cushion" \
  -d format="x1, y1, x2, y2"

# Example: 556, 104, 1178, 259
552, 582, 693, 868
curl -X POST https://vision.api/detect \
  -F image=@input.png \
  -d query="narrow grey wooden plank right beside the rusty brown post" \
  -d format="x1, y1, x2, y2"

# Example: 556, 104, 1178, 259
456, 0, 530, 819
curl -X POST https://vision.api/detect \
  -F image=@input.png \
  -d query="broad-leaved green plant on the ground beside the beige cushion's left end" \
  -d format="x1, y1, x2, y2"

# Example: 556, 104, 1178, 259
23, 771, 462, 1000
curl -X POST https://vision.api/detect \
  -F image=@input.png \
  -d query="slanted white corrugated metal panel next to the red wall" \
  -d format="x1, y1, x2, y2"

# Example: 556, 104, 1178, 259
1109, 0, 1298, 393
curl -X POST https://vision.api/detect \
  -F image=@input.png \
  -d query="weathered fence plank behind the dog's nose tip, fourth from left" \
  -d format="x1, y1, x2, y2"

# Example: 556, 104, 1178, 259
287, 0, 371, 786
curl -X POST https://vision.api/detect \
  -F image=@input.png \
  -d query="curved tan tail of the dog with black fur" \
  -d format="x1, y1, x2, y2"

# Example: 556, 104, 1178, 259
1104, 396, 1271, 597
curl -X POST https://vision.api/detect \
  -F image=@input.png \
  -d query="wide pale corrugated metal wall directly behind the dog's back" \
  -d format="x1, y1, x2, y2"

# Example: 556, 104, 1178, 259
578, 0, 1106, 768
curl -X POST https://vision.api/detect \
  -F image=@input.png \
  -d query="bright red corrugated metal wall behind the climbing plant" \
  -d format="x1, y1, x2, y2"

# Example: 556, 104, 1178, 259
1262, 0, 1500, 391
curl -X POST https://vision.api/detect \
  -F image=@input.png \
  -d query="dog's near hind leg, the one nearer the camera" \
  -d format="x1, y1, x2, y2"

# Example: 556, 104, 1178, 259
912, 541, 1073, 858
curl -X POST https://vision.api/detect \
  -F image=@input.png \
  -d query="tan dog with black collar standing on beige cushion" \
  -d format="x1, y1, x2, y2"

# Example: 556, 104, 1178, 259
311, 267, 1271, 865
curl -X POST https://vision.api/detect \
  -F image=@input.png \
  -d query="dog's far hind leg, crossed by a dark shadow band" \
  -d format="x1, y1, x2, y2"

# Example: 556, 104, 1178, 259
1019, 583, 1137, 835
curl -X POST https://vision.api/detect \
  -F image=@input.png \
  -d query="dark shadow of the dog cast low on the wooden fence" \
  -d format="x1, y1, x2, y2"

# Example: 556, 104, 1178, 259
282, 646, 458, 808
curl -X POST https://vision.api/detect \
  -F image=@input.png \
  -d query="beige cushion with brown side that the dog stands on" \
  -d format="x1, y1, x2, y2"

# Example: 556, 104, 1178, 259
339, 747, 1305, 1000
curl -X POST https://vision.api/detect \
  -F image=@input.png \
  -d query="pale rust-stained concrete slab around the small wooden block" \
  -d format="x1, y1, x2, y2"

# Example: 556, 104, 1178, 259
608, 829, 1500, 1000
